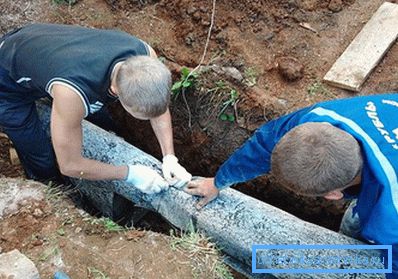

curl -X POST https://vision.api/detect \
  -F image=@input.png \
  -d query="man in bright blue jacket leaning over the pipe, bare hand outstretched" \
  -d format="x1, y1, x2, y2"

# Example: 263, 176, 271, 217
185, 93, 398, 278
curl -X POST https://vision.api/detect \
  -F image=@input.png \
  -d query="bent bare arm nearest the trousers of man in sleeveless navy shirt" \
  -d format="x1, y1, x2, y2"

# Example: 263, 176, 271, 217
51, 84, 128, 180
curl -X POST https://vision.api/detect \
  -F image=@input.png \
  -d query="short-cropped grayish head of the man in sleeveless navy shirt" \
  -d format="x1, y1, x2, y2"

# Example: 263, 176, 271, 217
112, 56, 171, 119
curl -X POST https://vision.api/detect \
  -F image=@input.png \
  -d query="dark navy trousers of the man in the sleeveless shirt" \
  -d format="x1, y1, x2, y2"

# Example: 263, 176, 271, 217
0, 67, 116, 181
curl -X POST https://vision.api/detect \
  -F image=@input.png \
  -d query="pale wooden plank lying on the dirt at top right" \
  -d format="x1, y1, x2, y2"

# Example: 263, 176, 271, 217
323, 2, 398, 91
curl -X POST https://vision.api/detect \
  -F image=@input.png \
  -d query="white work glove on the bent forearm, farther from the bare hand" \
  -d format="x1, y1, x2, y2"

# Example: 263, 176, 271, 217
126, 165, 169, 194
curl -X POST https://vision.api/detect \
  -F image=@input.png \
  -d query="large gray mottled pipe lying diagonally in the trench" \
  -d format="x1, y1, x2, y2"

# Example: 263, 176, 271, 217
38, 104, 384, 278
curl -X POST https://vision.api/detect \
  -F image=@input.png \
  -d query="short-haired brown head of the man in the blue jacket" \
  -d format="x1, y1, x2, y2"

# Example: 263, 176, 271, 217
271, 122, 362, 199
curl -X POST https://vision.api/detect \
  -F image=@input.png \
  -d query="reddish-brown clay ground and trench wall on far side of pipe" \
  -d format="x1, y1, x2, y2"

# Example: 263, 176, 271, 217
0, 0, 398, 278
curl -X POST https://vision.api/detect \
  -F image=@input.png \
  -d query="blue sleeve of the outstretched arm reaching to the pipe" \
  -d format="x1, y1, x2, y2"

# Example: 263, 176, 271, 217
215, 107, 312, 189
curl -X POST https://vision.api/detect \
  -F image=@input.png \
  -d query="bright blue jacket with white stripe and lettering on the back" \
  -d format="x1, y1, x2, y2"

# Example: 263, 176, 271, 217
215, 93, 398, 278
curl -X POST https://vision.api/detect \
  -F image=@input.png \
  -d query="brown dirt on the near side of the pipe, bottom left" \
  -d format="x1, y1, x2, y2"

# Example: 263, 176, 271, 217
0, 179, 233, 279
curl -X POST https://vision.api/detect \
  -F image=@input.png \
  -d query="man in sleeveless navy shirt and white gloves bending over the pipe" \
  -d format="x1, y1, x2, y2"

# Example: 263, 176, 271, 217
0, 24, 191, 193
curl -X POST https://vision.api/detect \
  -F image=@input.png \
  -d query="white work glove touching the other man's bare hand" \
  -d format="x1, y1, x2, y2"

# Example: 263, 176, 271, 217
162, 154, 192, 188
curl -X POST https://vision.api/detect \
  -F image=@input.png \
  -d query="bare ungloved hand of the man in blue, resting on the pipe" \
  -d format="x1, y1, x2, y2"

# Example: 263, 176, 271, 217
184, 178, 219, 210
